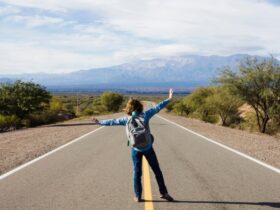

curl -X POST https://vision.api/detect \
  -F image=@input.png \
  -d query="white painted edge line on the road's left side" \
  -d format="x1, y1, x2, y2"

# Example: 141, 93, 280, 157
0, 126, 104, 180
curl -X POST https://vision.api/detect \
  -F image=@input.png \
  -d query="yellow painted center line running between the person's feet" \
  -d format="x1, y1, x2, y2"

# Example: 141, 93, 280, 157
143, 157, 154, 210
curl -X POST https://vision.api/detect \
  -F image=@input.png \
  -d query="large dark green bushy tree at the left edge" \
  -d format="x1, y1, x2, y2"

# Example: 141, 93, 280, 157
0, 81, 53, 131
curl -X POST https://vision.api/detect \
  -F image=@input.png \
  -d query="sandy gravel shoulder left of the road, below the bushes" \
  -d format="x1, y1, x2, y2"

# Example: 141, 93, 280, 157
0, 113, 125, 174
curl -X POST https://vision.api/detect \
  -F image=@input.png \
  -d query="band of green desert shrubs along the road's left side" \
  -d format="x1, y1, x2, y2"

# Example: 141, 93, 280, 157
0, 81, 125, 132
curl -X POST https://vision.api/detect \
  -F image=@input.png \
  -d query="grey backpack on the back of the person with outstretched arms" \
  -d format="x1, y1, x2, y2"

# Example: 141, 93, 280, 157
126, 116, 152, 149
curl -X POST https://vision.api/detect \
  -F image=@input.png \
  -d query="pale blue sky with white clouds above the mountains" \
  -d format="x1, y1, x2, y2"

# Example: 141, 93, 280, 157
0, 0, 280, 74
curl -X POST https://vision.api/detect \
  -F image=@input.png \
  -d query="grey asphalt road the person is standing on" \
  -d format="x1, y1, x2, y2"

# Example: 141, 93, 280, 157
0, 117, 280, 210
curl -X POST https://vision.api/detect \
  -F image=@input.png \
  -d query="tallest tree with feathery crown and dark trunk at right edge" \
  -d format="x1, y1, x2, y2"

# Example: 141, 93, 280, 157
216, 57, 280, 133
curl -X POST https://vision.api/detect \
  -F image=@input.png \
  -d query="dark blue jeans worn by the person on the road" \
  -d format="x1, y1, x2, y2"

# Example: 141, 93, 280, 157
132, 147, 167, 198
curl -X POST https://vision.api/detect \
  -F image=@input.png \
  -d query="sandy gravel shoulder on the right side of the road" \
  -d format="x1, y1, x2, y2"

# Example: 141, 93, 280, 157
160, 112, 280, 168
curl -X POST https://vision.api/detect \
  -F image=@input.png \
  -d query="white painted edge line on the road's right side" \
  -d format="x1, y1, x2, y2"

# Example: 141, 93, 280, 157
157, 115, 280, 174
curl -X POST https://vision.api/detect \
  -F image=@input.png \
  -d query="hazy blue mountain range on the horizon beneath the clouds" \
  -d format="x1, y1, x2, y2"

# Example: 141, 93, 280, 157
0, 54, 272, 89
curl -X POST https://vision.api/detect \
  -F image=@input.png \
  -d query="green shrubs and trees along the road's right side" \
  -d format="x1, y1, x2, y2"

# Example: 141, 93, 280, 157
167, 57, 280, 134
